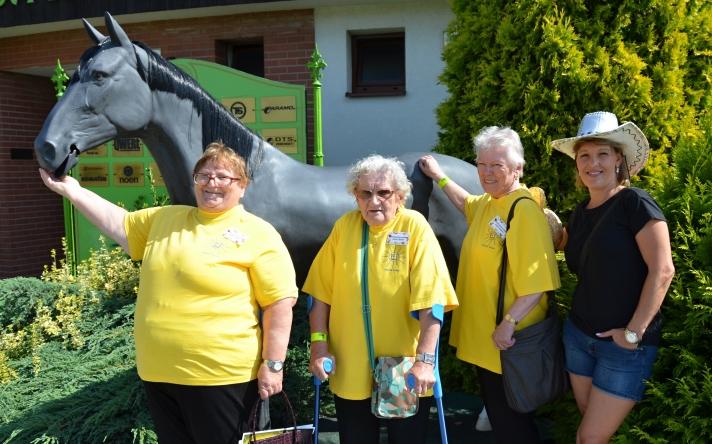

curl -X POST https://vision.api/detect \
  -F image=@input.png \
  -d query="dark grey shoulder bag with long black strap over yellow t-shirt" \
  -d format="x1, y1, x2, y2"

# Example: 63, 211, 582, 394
497, 197, 569, 413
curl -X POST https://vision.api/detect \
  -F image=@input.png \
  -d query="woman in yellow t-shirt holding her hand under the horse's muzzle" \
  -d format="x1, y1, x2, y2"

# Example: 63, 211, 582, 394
40, 143, 297, 444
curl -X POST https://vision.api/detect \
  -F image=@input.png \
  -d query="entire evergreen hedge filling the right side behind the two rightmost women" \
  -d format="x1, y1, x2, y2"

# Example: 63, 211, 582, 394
436, 0, 712, 443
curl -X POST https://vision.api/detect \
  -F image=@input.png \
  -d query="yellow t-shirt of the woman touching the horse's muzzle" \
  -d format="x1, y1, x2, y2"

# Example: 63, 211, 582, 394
124, 205, 297, 385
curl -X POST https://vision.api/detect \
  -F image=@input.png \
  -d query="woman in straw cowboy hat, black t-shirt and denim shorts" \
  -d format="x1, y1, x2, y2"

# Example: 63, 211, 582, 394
552, 111, 675, 443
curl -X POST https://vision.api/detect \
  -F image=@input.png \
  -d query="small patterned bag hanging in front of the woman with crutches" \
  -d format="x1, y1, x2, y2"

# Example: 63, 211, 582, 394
371, 356, 418, 418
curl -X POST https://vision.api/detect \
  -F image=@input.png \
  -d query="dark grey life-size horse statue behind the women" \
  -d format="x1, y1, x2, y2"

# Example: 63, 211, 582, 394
34, 12, 482, 285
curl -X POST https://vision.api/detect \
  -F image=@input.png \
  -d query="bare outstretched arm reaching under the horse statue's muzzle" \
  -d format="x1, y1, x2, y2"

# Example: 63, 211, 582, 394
40, 168, 129, 252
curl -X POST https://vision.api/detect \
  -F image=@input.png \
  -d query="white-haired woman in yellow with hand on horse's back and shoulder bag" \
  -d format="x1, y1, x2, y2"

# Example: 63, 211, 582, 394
420, 126, 560, 444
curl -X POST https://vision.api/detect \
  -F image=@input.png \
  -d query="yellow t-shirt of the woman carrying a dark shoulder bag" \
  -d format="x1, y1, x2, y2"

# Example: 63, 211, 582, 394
450, 188, 561, 374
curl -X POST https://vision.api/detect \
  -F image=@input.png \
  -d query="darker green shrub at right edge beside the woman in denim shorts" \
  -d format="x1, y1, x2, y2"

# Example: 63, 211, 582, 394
616, 115, 712, 443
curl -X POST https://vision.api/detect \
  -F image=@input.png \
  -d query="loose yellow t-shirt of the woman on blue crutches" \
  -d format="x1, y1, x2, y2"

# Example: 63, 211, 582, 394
304, 208, 457, 399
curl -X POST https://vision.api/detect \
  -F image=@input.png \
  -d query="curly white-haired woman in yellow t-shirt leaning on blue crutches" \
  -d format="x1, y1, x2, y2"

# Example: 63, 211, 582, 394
303, 155, 457, 444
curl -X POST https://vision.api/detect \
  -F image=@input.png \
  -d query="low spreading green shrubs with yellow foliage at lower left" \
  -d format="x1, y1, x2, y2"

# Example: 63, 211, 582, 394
0, 243, 318, 444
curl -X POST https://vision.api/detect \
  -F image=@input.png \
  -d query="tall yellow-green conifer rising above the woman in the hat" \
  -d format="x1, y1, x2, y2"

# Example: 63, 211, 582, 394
436, 0, 712, 213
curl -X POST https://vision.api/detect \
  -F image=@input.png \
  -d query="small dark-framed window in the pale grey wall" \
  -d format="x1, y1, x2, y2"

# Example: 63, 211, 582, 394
346, 32, 405, 97
